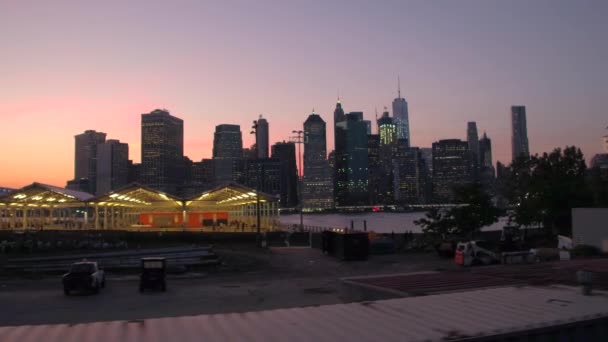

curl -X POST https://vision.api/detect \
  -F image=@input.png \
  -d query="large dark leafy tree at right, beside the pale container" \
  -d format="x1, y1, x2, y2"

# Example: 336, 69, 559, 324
504, 146, 593, 235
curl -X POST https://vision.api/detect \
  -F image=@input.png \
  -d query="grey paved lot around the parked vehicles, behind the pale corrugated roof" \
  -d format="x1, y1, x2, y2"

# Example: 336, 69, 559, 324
0, 247, 455, 326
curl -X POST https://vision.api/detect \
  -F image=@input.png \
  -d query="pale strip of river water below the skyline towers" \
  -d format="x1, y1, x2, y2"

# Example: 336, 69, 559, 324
281, 212, 506, 233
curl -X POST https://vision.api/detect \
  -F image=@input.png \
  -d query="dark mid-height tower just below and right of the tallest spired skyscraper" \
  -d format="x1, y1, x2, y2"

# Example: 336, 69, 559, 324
393, 145, 430, 204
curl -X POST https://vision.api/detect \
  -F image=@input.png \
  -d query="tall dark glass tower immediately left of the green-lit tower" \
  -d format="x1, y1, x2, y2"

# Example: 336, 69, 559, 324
334, 112, 369, 206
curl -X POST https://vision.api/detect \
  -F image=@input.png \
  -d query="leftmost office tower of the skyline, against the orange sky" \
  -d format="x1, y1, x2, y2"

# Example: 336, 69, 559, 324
71, 130, 106, 194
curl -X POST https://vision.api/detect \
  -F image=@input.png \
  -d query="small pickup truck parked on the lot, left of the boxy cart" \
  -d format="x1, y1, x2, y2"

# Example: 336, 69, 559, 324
63, 261, 106, 296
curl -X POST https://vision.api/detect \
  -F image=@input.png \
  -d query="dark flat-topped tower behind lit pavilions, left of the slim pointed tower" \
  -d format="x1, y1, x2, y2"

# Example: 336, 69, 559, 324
213, 124, 243, 185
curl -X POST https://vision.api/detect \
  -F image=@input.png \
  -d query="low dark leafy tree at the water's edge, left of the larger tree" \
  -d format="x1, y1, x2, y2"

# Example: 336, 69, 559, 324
414, 183, 500, 240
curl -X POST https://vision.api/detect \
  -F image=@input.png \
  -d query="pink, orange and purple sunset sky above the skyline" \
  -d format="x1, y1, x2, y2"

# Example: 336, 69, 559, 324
0, 0, 608, 187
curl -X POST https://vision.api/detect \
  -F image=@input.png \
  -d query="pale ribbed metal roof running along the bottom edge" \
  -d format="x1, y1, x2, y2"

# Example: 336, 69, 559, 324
0, 287, 608, 342
